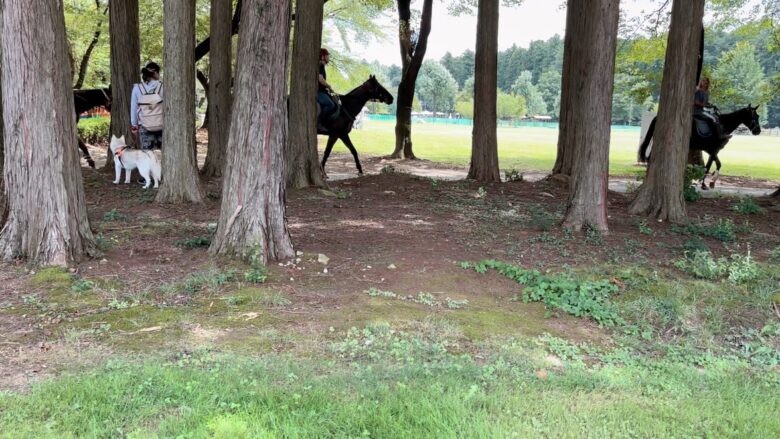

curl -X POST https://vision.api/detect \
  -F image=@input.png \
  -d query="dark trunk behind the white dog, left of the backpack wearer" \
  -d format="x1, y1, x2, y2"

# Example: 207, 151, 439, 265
106, 0, 141, 160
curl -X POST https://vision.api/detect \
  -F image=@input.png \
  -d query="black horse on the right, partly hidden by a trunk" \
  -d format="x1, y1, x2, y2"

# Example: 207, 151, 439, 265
639, 105, 761, 189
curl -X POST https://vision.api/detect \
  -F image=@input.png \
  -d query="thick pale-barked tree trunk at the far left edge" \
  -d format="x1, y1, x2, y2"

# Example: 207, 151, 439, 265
0, 0, 95, 266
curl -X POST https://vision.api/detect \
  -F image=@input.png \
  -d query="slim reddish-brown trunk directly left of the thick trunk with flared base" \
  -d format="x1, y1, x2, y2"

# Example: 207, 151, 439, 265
202, 0, 233, 177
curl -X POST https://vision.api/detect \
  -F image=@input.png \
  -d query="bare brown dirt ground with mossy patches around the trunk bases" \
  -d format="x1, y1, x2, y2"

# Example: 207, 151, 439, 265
0, 138, 780, 390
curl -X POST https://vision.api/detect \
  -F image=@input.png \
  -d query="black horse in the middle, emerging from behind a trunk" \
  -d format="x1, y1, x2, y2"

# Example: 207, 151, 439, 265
317, 75, 393, 175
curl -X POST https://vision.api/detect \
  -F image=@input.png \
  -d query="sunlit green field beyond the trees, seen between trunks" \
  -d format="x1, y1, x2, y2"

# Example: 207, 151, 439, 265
334, 121, 780, 180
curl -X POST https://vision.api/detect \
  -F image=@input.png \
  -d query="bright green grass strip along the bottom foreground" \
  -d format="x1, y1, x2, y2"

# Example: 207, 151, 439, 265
0, 340, 780, 438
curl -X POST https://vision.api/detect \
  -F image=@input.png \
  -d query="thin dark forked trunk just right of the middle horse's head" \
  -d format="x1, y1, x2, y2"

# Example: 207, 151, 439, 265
390, 0, 433, 159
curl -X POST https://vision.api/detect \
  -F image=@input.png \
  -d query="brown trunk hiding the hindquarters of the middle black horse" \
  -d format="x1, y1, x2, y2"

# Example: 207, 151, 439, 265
285, 0, 326, 189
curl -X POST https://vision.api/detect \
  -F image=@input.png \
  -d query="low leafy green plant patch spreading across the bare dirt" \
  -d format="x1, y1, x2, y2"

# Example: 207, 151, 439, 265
461, 260, 625, 326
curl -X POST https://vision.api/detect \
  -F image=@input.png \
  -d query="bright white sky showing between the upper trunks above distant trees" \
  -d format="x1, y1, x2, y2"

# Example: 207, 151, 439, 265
352, 0, 652, 65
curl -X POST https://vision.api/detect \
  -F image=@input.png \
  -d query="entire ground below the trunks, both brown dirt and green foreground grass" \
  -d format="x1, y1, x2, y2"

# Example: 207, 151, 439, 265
0, 171, 780, 439
